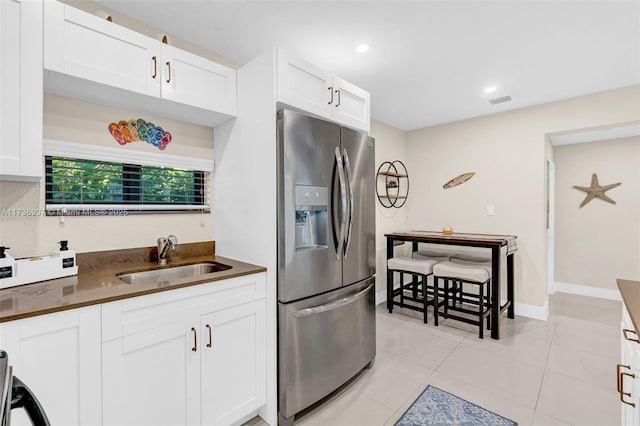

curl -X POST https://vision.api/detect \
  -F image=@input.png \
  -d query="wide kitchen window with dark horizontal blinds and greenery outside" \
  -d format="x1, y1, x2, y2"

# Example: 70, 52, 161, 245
45, 156, 210, 215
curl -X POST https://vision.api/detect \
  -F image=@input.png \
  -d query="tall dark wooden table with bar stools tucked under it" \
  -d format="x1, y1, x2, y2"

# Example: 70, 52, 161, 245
385, 231, 517, 340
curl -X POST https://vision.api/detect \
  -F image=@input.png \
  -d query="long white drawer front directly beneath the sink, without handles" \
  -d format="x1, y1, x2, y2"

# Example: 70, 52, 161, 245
102, 273, 265, 342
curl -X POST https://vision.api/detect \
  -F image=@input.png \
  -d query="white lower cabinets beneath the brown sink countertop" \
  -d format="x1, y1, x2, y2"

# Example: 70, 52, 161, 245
0, 273, 266, 426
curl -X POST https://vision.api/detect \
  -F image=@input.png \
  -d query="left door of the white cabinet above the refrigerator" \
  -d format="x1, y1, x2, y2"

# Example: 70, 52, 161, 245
276, 49, 335, 119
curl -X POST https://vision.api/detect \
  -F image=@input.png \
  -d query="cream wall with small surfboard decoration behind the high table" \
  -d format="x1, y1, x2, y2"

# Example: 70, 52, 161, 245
406, 85, 640, 312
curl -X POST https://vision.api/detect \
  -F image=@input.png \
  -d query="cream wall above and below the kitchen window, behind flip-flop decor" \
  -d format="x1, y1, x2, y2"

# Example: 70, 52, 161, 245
0, 94, 214, 257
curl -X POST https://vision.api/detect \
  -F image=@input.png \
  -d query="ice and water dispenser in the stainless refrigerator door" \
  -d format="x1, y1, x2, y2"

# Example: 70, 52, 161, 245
295, 185, 327, 251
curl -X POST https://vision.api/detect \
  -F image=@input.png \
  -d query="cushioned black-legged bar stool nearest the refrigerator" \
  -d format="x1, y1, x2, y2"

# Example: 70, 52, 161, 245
387, 256, 444, 325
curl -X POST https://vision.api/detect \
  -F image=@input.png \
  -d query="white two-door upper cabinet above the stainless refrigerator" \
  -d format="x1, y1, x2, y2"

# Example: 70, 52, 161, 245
276, 49, 371, 132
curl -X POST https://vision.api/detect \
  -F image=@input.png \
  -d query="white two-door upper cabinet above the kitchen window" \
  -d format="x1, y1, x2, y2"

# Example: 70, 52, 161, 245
44, 0, 236, 126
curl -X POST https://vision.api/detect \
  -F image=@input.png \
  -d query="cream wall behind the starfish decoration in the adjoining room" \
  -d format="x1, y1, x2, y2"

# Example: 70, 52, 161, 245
554, 137, 640, 290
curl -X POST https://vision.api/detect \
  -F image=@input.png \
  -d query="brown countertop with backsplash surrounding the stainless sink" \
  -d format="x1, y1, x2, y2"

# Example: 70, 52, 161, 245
0, 244, 266, 323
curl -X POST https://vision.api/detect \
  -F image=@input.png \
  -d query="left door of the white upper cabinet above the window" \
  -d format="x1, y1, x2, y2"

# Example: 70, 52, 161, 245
44, 1, 161, 96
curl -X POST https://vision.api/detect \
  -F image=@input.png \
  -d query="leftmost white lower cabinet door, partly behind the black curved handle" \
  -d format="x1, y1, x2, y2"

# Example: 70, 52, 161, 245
0, 306, 102, 425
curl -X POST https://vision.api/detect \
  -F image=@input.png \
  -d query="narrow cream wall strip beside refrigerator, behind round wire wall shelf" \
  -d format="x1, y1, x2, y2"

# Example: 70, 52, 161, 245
370, 121, 412, 291
